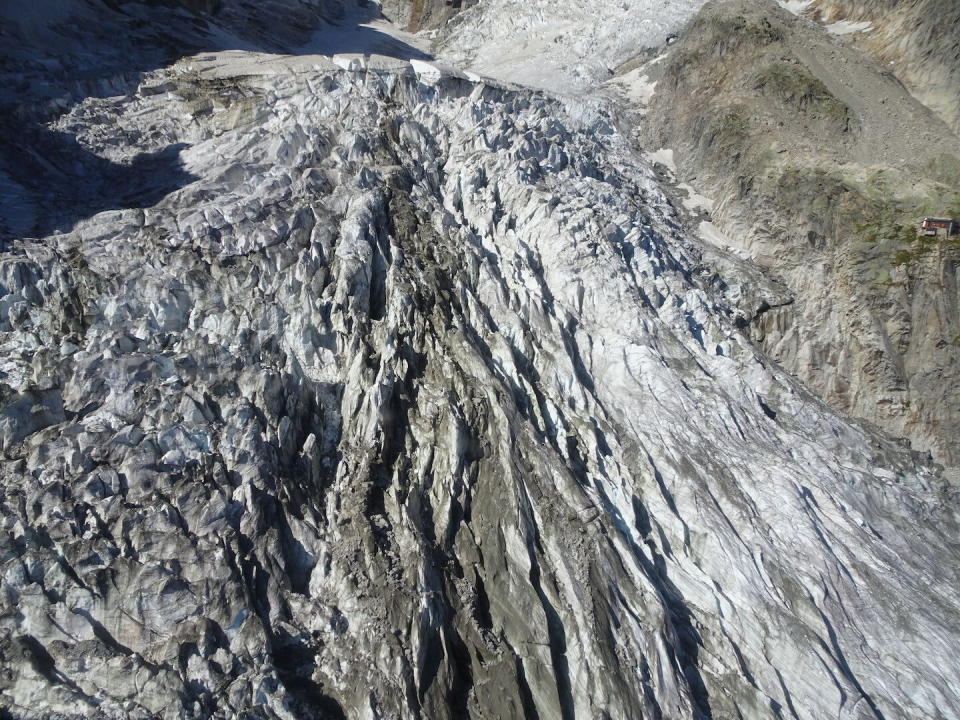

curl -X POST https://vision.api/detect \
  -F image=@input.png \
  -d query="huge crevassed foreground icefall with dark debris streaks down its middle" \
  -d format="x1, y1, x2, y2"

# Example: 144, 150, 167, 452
0, 1, 960, 720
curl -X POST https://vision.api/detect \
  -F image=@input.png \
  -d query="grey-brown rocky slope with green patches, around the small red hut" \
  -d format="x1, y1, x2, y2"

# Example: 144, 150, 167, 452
634, 1, 960, 466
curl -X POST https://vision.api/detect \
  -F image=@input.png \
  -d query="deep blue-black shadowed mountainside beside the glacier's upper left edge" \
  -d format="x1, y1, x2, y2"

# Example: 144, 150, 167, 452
0, 0, 428, 242
